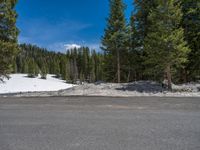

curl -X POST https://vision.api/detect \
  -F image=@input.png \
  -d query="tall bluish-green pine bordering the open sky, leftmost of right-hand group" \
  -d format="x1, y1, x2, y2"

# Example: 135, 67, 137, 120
102, 0, 127, 83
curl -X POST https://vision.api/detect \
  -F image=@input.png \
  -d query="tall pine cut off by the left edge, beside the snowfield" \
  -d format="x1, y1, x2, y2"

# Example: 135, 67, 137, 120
0, 0, 19, 78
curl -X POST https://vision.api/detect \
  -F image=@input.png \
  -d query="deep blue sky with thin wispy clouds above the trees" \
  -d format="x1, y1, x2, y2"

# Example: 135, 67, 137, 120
16, 0, 133, 52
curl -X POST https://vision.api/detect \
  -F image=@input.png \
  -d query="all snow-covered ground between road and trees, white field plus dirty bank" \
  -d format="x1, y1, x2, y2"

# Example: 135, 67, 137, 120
0, 74, 200, 97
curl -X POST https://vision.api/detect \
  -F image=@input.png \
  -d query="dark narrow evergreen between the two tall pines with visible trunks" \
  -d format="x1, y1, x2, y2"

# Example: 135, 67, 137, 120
129, 0, 157, 80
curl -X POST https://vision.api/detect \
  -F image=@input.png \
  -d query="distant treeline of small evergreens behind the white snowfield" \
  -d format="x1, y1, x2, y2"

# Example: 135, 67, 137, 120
13, 44, 103, 82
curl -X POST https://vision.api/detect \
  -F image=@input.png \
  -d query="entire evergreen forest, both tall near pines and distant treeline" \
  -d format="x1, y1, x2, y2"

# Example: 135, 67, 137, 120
0, 0, 200, 90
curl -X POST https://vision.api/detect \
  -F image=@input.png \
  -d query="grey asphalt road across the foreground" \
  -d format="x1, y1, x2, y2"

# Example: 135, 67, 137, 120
0, 97, 200, 150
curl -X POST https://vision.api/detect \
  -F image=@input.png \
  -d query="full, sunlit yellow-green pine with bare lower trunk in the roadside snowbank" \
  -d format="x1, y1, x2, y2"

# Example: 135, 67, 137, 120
145, 0, 189, 90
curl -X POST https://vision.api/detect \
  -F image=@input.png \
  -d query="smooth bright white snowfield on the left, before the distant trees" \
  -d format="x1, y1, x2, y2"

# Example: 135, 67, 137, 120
0, 74, 73, 94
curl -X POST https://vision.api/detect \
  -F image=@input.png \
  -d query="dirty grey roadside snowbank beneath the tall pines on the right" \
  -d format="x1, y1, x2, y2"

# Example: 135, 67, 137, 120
58, 81, 200, 97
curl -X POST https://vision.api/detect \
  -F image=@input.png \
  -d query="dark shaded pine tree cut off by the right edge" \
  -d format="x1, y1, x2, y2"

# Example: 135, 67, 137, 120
181, 0, 200, 81
